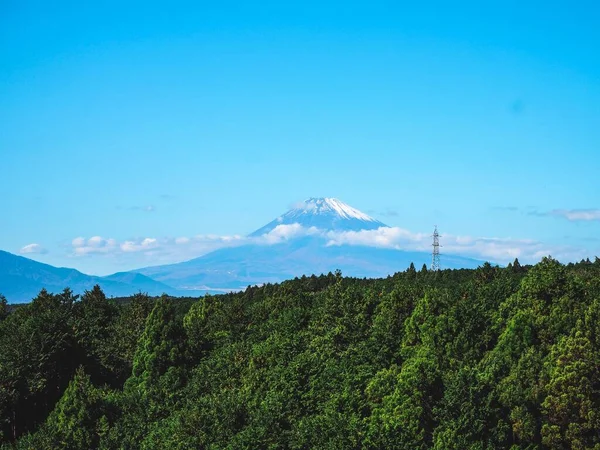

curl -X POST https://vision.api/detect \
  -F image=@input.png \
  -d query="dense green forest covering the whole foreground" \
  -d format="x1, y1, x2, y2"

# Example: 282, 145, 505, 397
0, 257, 600, 450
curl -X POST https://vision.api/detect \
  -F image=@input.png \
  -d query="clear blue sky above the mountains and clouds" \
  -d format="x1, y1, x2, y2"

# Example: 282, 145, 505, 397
0, 0, 600, 274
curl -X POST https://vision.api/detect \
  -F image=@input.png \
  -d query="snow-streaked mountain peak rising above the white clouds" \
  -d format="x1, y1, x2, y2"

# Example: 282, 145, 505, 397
250, 197, 387, 237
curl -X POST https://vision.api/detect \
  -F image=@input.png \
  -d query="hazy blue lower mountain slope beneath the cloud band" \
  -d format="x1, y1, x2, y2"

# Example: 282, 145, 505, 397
138, 237, 482, 289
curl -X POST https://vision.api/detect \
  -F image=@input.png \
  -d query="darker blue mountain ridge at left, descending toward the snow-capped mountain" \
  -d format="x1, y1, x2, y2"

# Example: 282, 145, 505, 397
0, 250, 178, 303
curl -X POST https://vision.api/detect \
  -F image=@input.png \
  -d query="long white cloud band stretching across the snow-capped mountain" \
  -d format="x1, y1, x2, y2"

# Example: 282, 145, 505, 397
71, 223, 590, 264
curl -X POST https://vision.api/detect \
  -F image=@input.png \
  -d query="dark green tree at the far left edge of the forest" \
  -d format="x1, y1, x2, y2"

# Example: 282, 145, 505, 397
0, 289, 79, 440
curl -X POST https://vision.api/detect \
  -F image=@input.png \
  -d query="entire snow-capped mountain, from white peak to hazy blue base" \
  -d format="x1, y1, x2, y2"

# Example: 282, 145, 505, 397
134, 198, 483, 291
